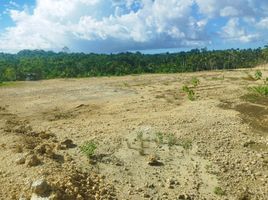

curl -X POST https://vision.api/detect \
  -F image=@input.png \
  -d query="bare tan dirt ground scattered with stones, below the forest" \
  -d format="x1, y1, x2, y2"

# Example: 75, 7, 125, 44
0, 66, 268, 200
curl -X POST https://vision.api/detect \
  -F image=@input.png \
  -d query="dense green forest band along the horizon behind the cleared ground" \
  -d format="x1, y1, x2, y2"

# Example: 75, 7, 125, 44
0, 46, 268, 81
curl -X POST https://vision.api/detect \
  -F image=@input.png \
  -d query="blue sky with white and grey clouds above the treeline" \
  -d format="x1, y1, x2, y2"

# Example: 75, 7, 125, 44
0, 0, 268, 53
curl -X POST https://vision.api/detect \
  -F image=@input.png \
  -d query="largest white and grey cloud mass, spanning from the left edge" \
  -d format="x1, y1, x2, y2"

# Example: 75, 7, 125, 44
0, 0, 209, 51
